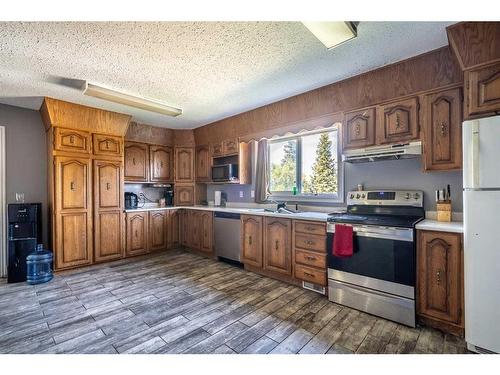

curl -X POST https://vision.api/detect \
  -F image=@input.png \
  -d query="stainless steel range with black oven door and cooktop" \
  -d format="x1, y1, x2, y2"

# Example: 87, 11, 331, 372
327, 190, 424, 327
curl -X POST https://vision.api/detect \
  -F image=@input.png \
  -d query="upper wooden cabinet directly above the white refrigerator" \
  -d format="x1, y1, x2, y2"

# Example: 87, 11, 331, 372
464, 63, 500, 118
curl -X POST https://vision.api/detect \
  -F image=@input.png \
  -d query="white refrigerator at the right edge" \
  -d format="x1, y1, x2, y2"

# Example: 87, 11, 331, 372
462, 116, 500, 353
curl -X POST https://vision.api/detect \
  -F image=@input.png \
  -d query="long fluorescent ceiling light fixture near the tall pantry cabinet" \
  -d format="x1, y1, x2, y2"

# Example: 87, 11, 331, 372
83, 82, 182, 117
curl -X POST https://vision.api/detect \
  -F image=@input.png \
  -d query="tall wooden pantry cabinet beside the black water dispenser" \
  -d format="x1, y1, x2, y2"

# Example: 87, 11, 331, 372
40, 98, 130, 270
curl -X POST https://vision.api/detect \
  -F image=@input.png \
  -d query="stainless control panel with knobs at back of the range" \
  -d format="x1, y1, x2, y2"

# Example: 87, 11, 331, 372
347, 190, 424, 207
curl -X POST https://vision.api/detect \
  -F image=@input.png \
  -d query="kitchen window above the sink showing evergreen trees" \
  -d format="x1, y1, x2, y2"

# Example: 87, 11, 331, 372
268, 126, 343, 202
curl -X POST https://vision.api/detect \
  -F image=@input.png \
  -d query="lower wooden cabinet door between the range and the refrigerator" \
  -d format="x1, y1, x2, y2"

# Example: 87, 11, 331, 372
417, 231, 462, 324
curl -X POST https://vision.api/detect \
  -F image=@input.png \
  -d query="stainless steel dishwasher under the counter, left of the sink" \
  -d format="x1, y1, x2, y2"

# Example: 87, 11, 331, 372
214, 211, 241, 262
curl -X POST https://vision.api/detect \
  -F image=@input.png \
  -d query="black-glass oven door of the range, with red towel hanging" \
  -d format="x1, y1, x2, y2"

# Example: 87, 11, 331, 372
328, 224, 415, 290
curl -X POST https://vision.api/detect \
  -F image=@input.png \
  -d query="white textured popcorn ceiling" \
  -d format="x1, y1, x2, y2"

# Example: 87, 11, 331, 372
0, 22, 450, 128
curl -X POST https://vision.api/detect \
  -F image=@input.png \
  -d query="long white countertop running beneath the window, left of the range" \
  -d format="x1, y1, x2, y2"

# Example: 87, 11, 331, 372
125, 206, 328, 222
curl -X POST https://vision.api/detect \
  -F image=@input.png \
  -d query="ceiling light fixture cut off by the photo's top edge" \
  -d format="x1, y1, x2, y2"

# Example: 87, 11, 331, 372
302, 21, 358, 49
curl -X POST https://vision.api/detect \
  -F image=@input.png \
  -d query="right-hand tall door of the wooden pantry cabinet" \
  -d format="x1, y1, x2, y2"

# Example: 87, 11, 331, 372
93, 160, 123, 261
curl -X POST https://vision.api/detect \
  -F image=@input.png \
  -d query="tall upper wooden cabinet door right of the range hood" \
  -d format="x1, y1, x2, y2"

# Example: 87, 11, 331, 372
423, 88, 462, 171
